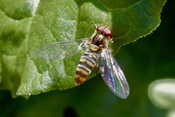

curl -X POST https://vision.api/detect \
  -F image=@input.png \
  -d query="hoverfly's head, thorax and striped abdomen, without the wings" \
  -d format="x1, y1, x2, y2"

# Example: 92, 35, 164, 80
75, 26, 112, 84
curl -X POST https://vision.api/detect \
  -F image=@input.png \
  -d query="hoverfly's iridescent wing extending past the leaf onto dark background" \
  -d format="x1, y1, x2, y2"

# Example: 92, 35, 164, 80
99, 49, 129, 99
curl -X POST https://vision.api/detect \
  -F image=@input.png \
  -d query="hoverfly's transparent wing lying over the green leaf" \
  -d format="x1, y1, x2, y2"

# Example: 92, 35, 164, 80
35, 38, 89, 59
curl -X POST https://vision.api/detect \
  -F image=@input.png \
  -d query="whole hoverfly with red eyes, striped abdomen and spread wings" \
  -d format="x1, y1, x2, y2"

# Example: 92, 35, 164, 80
35, 26, 129, 99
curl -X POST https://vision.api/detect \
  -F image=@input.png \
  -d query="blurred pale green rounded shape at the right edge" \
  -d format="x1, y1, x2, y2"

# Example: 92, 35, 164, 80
148, 78, 175, 110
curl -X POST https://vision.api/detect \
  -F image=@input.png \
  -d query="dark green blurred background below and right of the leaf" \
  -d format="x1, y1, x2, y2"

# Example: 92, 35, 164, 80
0, 0, 175, 117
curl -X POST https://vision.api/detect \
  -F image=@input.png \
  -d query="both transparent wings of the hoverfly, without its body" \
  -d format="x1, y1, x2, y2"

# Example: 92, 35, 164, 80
35, 38, 129, 99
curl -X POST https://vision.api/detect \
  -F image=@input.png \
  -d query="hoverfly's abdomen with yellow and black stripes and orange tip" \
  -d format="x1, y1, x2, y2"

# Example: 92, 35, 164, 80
75, 49, 99, 84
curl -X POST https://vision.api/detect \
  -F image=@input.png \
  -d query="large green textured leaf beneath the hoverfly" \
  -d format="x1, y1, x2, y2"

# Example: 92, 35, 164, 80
0, 0, 166, 96
